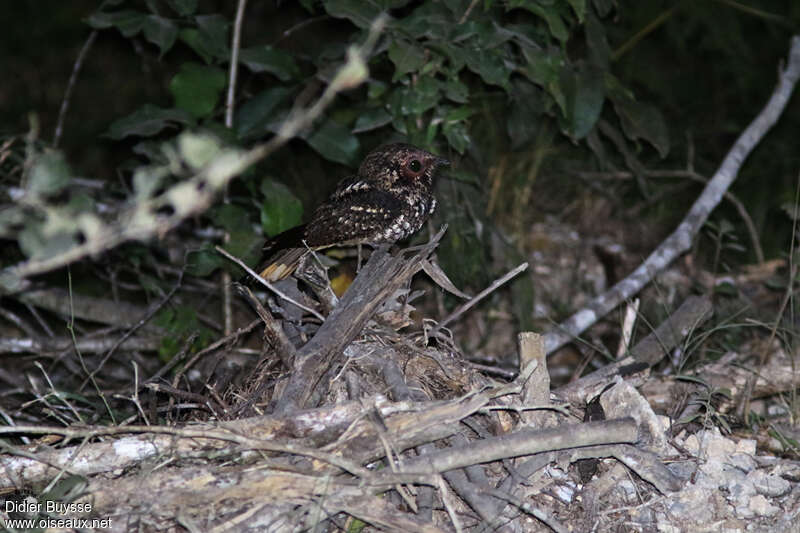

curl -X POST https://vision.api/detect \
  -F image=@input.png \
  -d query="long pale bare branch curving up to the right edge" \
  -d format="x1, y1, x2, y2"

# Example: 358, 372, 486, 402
545, 36, 800, 353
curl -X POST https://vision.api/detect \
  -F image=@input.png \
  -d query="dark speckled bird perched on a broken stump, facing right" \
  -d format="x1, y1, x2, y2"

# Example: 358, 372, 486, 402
257, 143, 450, 281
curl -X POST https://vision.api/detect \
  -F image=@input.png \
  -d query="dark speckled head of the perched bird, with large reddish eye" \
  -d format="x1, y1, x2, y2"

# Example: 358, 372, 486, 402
358, 143, 450, 187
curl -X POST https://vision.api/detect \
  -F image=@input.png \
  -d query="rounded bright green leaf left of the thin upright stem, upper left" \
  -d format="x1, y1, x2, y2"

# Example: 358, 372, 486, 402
169, 63, 226, 118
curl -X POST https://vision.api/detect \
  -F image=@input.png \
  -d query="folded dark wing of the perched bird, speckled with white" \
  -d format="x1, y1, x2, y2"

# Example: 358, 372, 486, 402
305, 187, 402, 247
